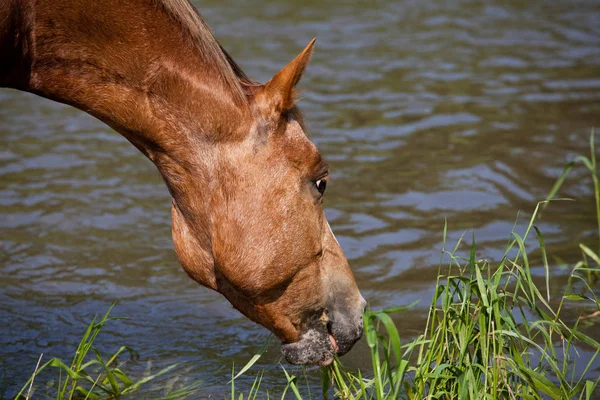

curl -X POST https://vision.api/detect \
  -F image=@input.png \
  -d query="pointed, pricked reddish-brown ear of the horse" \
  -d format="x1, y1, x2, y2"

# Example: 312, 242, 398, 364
264, 38, 316, 112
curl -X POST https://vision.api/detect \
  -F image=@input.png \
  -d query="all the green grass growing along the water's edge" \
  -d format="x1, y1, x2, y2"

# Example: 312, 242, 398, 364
12, 132, 600, 400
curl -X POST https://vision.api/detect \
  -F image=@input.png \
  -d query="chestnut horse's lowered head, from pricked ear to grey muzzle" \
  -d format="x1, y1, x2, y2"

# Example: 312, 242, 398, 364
172, 40, 365, 364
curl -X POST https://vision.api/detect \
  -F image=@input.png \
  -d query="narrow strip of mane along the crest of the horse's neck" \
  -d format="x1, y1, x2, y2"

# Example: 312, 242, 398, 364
156, 0, 257, 104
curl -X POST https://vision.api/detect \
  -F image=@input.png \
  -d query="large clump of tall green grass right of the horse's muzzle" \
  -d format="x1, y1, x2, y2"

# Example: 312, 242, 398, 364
323, 216, 600, 399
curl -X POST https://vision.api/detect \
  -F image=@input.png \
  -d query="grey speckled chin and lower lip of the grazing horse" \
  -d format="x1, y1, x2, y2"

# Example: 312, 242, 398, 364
281, 325, 337, 365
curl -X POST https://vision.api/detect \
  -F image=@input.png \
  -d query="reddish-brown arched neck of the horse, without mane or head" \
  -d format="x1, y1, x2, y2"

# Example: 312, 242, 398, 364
0, 0, 248, 166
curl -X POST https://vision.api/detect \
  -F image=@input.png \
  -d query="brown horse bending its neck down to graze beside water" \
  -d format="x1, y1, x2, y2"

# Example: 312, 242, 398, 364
0, 0, 365, 364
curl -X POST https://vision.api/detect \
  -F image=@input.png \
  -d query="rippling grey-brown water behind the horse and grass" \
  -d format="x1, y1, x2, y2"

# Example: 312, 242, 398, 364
0, 1, 600, 397
